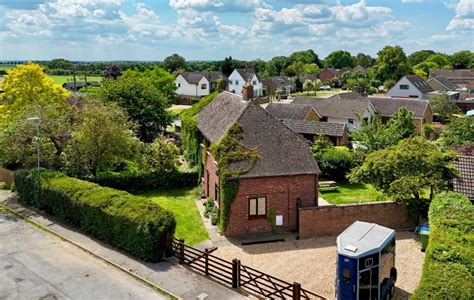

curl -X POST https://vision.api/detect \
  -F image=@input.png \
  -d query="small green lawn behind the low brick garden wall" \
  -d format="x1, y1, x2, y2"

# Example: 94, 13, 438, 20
320, 183, 388, 204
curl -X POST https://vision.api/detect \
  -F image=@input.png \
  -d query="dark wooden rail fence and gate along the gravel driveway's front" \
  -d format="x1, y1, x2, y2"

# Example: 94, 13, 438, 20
172, 239, 325, 299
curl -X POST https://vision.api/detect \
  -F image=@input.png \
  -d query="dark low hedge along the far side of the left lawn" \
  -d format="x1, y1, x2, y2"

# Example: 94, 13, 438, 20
88, 171, 198, 192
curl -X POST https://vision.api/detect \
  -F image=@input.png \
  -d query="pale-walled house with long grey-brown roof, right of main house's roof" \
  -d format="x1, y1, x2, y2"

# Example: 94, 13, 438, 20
292, 93, 376, 130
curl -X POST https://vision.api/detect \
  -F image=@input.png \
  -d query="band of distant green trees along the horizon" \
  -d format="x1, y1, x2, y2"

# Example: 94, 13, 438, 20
3, 46, 474, 83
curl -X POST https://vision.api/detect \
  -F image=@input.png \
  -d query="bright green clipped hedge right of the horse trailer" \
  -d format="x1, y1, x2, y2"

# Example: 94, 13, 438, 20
411, 192, 474, 299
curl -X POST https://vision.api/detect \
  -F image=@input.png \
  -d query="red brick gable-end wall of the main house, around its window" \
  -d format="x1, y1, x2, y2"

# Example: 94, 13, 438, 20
226, 175, 318, 236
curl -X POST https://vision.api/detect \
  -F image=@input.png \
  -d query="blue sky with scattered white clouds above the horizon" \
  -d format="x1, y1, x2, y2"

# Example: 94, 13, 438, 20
0, 0, 474, 60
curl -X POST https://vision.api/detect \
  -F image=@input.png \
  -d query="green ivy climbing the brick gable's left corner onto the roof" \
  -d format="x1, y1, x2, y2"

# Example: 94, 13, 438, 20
212, 123, 259, 232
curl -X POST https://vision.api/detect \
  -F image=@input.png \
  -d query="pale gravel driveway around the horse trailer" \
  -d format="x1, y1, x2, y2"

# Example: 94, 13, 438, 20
213, 232, 424, 299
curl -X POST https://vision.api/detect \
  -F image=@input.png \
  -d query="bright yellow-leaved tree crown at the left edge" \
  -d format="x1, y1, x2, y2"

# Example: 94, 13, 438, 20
0, 62, 69, 124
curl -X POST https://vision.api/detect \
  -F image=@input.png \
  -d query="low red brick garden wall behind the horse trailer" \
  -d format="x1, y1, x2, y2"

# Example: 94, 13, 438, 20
299, 202, 415, 238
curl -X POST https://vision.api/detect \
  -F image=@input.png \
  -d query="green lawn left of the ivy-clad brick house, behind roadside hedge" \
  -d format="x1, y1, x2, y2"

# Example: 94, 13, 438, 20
139, 188, 209, 245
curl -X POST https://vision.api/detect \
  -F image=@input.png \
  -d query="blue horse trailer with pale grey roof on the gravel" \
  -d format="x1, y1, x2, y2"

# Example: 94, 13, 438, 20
336, 221, 397, 300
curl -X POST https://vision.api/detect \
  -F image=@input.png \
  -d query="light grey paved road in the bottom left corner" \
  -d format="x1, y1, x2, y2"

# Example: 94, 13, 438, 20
0, 211, 164, 299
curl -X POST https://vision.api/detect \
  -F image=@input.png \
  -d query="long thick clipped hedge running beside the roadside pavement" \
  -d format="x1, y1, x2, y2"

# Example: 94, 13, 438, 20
15, 170, 176, 261
